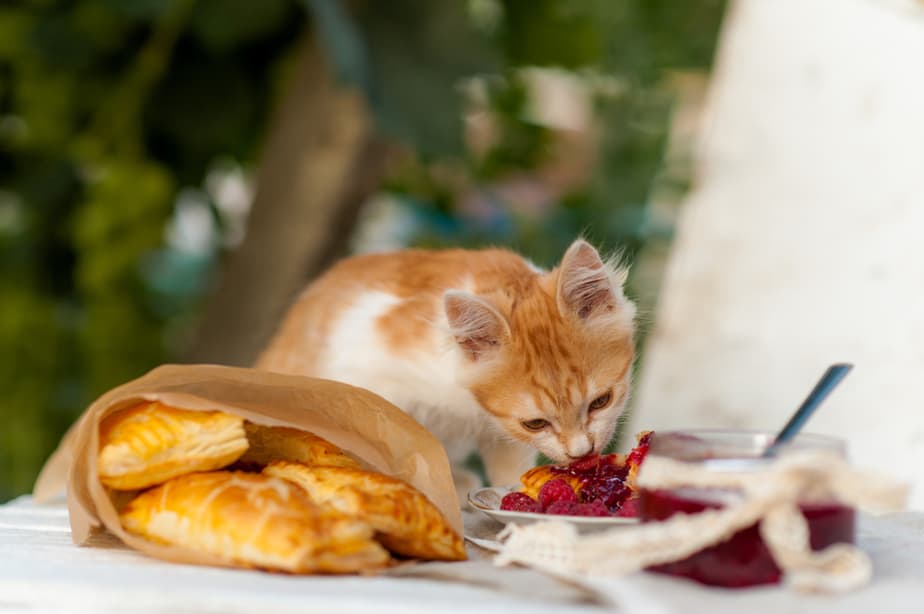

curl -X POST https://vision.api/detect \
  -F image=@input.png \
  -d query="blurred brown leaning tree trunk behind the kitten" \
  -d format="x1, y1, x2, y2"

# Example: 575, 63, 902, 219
186, 36, 386, 365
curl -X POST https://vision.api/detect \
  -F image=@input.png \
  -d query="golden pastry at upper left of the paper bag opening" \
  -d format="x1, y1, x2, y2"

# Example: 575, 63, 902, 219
97, 401, 247, 490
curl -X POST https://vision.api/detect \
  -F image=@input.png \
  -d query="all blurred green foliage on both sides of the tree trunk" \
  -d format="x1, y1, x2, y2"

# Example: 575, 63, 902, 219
0, 0, 724, 500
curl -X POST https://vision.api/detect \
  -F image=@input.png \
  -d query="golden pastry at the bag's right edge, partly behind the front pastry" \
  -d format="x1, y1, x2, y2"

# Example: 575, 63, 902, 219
263, 461, 466, 561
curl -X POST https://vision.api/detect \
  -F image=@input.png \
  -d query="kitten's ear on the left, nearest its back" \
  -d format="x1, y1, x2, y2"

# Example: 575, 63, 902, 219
443, 290, 510, 361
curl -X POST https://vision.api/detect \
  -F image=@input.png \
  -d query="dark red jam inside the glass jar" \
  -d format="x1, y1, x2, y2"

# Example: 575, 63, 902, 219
638, 489, 855, 588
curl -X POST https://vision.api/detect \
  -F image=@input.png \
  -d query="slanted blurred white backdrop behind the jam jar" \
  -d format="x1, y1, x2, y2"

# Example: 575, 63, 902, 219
632, 0, 924, 509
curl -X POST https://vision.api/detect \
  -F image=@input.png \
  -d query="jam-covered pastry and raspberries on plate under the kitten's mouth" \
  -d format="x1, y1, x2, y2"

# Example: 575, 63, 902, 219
501, 431, 652, 517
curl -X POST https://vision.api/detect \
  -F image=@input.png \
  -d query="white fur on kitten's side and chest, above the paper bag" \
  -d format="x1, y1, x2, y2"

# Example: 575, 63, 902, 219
317, 291, 491, 461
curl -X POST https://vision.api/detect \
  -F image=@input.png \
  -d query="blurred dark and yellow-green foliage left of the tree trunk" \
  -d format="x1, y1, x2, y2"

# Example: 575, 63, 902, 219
0, 0, 305, 500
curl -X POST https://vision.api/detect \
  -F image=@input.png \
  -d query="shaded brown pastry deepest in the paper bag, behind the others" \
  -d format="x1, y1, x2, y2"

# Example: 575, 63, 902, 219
240, 422, 360, 469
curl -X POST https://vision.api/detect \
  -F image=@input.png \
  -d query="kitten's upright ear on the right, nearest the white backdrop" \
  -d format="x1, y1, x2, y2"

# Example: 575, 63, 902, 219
558, 239, 631, 320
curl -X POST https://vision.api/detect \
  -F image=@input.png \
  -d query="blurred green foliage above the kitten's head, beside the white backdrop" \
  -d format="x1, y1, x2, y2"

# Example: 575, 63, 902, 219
378, 0, 725, 265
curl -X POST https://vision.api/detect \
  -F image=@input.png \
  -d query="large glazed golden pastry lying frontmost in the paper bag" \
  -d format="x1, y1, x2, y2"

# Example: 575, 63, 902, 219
119, 471, 390, 573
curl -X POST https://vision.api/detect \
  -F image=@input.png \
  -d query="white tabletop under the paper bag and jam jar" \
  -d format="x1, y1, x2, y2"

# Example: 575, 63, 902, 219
0, 497, 924, 614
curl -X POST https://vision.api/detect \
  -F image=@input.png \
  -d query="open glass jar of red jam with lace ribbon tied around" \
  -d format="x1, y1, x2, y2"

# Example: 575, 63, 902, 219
639, 430, 856, 587
